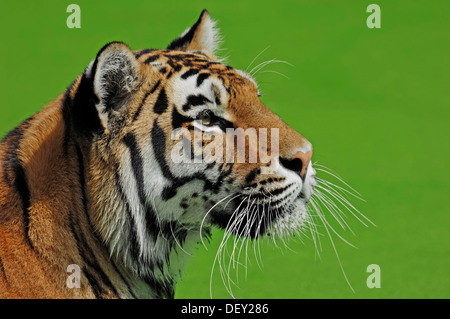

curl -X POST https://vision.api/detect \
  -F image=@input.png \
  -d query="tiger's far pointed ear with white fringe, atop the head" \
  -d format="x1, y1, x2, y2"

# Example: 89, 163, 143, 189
167, 9, 220, 54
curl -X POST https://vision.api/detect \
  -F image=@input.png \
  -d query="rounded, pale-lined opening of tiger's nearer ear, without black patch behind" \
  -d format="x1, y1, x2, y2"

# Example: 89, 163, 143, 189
85, 42, 140, 127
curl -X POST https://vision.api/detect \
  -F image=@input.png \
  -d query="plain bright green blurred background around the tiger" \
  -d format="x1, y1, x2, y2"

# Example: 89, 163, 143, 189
0, 0, 450, 298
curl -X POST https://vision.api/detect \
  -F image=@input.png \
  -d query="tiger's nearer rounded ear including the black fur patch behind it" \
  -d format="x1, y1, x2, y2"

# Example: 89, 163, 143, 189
69, 42, 143, 138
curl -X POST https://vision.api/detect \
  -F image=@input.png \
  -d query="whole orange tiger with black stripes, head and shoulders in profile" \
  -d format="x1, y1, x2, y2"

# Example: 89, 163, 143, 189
0, 10, 316, 298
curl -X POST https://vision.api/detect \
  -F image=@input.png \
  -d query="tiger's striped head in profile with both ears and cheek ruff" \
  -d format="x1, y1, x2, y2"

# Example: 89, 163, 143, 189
66, 10, 315, 278
